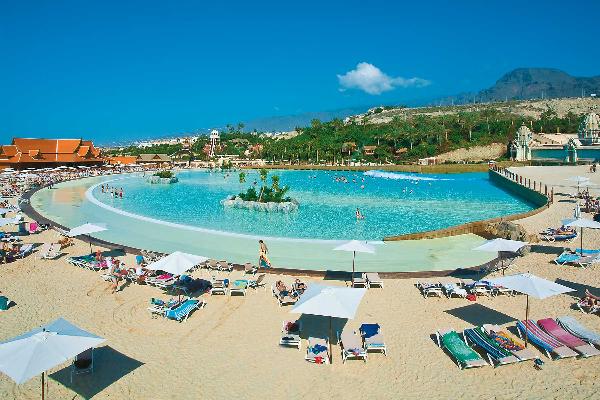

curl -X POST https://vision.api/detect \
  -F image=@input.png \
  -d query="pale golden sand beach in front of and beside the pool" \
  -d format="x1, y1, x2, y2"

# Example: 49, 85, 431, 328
0, 167, 600, 399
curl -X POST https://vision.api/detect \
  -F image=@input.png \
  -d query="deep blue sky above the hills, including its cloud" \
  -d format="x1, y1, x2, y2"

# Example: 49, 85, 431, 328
0, 0, 600, 142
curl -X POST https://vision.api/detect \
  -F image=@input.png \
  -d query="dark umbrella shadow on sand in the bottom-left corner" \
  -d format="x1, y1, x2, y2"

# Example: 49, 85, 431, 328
49, 346, 143, 399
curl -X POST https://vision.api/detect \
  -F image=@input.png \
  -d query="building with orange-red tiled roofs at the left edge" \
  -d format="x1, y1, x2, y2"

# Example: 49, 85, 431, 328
0, 138, 104, 169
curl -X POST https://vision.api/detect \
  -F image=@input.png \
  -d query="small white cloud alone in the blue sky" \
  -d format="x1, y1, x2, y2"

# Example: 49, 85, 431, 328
337, 62, 431, 95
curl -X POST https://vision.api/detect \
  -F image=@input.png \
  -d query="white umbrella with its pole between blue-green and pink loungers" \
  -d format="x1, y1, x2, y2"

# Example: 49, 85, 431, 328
489, 273, 575, 346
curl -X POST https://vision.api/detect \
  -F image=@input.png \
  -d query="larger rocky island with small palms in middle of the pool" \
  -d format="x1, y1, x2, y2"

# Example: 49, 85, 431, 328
221, 169, 298, 213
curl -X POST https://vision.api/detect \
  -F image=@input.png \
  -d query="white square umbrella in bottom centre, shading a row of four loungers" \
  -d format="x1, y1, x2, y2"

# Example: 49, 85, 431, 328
290, 283, 367, 364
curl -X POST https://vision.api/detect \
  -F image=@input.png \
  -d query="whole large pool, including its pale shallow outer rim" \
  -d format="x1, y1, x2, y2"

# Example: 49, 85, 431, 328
31, 170, 534, 271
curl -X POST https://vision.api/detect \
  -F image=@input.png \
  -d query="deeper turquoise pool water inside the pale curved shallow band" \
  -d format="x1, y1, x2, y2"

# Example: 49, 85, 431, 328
92, 170, 533, 240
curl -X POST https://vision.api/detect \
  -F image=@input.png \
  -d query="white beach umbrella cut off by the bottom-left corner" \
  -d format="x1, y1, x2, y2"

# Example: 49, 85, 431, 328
0, 318, 105, 399
